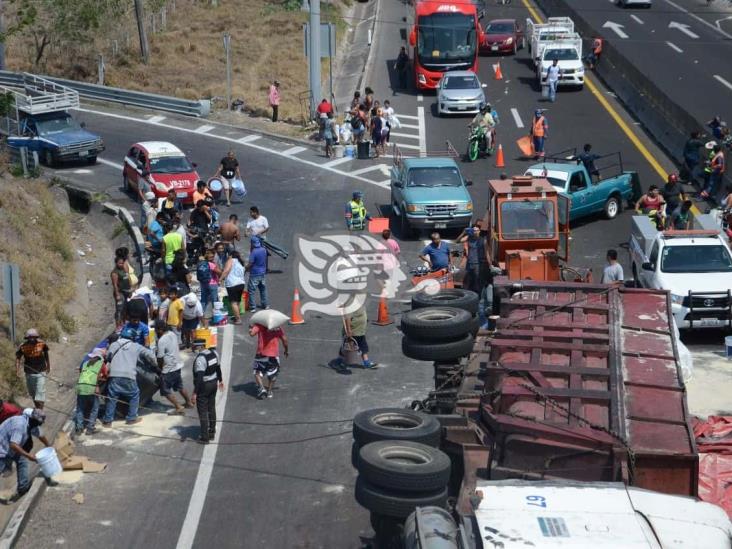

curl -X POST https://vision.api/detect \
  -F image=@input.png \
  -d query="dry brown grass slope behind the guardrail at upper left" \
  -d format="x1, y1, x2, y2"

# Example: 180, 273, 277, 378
8, 0, 350, 122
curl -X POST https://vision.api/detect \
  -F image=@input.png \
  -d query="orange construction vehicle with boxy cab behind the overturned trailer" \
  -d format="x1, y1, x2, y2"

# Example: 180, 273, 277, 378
481, 176, 592, 282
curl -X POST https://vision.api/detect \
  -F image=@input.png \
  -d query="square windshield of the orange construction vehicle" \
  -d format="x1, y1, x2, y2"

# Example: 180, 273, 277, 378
501, 199, 555, 240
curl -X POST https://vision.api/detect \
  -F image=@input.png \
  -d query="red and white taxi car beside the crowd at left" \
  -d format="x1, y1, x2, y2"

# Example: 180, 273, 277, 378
122, 141, 201, 204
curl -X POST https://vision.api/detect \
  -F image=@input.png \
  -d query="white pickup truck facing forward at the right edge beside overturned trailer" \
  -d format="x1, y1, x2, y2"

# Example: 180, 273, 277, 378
630, 214, 732, 330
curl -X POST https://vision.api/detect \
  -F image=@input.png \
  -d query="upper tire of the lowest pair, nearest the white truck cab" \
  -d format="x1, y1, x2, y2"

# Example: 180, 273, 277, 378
356, 440, 450, 492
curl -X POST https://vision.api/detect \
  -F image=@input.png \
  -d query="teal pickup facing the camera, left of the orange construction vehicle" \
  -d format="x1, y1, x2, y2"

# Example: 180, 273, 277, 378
391, 147, 473, 238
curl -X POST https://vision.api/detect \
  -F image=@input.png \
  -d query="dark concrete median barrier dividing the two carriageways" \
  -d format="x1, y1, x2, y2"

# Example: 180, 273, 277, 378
534, 0, 732, 191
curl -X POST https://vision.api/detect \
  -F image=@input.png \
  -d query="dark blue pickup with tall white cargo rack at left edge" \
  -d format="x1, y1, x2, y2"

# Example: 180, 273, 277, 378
0, 74, 104, 166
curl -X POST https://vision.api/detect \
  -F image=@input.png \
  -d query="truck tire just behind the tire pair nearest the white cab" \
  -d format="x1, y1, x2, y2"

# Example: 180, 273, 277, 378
353, 408, 442, 447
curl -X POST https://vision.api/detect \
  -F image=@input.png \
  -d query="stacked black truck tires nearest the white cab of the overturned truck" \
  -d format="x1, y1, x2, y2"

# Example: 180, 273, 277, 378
351, 408, 450, 521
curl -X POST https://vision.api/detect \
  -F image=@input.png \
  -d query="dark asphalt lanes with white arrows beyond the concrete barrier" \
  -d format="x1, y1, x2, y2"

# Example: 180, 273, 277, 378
566, 0, 732, 121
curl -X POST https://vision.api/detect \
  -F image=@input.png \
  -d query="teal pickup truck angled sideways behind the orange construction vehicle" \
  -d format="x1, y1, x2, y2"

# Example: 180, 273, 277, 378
524, 155, 641, 221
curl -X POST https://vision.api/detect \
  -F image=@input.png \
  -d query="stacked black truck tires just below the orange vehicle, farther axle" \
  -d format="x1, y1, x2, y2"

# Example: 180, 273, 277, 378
401, 288, 479, 362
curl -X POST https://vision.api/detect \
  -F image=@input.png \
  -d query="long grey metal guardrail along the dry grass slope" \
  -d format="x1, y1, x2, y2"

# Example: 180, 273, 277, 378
0, 71, 211, 117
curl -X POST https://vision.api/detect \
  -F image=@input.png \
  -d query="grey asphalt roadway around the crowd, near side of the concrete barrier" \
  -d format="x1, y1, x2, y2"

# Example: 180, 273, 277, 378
14, 0, 728, 548
